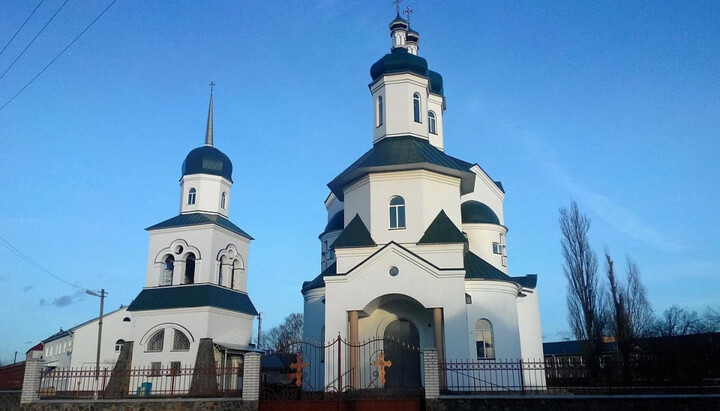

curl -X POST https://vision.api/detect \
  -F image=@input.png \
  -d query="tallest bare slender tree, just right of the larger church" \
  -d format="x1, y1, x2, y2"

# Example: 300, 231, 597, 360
560, 201, 605, 369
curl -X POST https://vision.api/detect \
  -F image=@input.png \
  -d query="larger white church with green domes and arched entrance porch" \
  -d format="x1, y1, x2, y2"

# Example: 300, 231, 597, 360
302, 13, 543, 382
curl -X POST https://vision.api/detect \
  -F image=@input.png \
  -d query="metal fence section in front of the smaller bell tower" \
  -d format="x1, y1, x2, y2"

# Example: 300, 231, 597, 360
39, 366, 243, 398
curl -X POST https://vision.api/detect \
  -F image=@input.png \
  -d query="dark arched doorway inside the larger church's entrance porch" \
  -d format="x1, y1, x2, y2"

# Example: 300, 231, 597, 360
383, 319, 421, 389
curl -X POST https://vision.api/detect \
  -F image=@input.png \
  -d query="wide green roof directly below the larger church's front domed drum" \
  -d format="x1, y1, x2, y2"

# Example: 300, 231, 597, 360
328, 136, 475, 201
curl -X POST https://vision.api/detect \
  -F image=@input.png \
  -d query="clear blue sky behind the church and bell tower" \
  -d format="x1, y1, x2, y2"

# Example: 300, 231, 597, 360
0, 0, 720, 363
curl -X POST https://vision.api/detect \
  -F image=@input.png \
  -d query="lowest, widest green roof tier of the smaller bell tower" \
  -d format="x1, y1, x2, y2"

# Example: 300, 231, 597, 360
127, 284, 257, 315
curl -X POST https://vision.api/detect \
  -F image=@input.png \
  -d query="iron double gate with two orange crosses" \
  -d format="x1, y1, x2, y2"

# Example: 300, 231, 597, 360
260, 336, 424, 401
